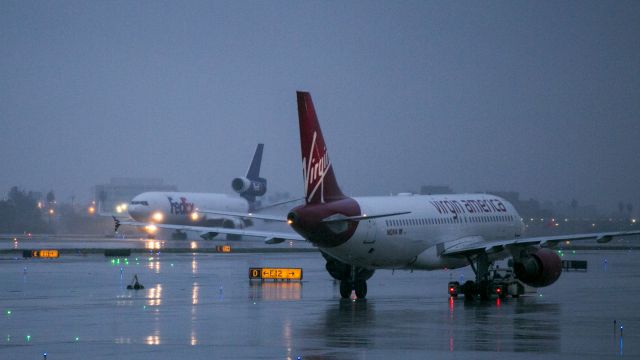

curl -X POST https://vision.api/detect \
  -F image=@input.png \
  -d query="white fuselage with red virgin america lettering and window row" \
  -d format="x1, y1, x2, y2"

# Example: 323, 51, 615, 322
322, 194, 524, 270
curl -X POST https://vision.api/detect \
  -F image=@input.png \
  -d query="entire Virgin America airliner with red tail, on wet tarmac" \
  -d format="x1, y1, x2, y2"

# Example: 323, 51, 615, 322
117, 92, 640, 299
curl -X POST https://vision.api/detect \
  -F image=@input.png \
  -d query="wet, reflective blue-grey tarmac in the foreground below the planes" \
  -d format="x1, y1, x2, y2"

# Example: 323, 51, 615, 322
0, 240, 640, 360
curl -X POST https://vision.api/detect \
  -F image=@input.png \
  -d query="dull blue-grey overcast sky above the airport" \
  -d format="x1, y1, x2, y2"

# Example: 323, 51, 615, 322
0, 0, 640, 209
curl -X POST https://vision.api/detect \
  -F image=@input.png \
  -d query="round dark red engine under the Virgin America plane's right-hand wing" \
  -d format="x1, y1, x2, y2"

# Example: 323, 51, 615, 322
513, 249, 562, 287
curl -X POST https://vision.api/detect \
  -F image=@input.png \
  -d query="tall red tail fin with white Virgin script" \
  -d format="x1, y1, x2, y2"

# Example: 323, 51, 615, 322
297, 91, 345, 204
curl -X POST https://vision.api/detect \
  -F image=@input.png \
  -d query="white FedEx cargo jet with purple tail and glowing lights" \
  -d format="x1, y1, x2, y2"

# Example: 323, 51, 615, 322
119, 144, 267, 239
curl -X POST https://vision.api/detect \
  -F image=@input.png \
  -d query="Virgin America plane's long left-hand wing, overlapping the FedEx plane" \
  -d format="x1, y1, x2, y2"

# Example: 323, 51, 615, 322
114, 218, 306, 244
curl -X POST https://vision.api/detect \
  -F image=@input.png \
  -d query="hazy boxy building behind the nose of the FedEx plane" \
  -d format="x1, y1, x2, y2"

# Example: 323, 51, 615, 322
94, 178, 178, 213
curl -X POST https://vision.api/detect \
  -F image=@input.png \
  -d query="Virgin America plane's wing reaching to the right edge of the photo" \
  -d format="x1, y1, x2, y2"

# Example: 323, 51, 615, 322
441, 230, 640, 257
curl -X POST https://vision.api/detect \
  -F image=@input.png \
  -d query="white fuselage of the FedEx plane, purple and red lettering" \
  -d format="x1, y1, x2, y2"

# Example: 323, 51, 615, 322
128, 192, 249, 225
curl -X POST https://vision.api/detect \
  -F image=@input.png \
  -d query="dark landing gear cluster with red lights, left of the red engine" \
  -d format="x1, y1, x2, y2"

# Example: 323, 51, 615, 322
448, 254, 524, 301
